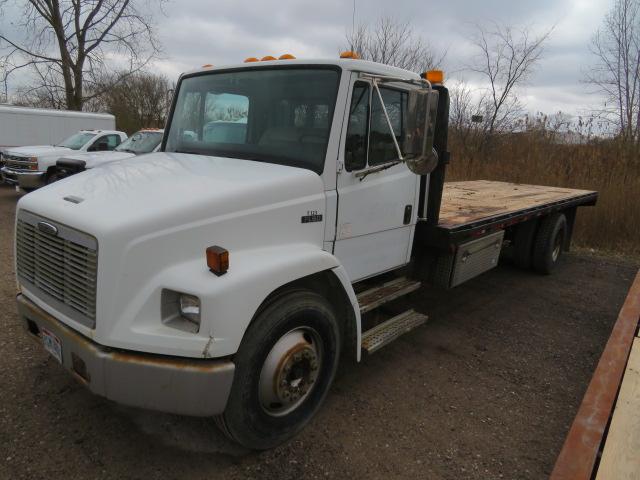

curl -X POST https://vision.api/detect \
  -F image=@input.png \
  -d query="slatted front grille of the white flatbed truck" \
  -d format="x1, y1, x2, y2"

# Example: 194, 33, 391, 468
16, 212, 98, 328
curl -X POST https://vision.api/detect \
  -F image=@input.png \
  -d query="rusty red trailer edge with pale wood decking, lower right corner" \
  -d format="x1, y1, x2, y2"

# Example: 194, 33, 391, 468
550, 272, 640, 480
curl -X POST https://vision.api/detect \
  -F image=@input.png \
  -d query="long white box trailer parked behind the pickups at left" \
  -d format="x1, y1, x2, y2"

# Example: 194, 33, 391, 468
0, 105, 116, 149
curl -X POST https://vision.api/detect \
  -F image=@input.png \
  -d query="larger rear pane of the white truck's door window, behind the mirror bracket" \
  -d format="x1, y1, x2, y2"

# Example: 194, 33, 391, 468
369, 88, 408, 165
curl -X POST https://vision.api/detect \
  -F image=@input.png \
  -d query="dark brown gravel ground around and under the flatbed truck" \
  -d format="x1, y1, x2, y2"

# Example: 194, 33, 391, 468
0, 182, 637, 480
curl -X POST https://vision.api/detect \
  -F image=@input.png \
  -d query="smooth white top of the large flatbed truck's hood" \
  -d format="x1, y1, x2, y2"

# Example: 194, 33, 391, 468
18, 152, 324, 239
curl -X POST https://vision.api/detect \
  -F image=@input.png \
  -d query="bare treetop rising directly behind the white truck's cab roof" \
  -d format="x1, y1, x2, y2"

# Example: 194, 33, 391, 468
345, 17, 446, 72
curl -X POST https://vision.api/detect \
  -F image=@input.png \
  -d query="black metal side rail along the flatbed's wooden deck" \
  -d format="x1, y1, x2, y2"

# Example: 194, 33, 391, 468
418, 192, 598, 248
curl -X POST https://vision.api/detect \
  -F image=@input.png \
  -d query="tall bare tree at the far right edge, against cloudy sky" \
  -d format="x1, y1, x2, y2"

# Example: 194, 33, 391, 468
586, 0, 640, 141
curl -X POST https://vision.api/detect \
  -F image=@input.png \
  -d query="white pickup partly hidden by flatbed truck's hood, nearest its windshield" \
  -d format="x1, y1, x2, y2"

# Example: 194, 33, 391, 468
56, 128, 163, 179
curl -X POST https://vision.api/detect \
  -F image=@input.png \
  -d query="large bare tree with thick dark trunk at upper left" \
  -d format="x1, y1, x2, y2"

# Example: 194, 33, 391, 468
0, 0, 163, 110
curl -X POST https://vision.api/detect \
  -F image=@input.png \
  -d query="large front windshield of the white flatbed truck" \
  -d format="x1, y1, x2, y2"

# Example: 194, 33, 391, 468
165, 67, 339, 173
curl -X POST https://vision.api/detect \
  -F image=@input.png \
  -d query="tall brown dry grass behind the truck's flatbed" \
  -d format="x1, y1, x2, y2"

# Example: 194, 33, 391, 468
447, 132, 640, 257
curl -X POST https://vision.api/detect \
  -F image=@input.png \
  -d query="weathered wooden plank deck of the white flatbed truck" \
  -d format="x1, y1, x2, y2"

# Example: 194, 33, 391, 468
439, 180, 593, 228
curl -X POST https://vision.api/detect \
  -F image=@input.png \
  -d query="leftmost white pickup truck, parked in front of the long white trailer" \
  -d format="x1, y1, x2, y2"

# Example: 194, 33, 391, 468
0, 130, 127, 190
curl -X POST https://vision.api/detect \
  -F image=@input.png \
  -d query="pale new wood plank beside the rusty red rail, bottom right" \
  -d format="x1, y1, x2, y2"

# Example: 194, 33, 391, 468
596, 338, 640, 480
